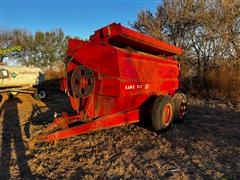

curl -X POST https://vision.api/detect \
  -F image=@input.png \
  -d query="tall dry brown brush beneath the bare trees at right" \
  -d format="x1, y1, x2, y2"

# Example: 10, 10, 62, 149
182, 63, 240, 101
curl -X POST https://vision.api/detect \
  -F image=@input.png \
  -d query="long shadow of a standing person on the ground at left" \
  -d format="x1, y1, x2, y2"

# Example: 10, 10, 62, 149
0, 98, 32, 179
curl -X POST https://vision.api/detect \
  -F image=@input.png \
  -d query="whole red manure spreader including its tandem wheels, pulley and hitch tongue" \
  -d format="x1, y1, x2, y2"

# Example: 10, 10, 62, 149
35, 23, 186, 141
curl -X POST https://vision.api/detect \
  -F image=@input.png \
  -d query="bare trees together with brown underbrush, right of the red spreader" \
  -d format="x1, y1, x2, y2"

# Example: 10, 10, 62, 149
130, 0, 240, 98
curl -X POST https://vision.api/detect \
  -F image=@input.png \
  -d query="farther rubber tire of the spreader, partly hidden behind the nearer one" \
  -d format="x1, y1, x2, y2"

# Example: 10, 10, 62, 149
173, 93, 187, 122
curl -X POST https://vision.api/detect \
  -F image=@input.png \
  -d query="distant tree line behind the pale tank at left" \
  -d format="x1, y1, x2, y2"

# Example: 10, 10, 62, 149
0, 29, 69, 68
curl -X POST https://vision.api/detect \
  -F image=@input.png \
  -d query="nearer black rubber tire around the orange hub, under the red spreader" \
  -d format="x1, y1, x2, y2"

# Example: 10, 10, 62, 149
152, 95, 174, 131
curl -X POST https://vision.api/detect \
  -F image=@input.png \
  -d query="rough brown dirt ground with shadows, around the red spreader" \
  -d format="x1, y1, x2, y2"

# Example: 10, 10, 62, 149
0, 94, 240, 179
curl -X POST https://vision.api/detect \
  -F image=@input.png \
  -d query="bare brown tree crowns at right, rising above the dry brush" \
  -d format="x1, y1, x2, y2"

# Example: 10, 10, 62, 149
131, 0, 240, 75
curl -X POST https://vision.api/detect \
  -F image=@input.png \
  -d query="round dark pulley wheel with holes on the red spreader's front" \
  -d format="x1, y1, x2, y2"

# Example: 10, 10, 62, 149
71, 66, 94, 98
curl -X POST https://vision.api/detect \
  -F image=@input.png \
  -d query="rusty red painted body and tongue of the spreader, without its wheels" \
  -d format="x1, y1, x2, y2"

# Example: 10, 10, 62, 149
34, 23, 182, 140
